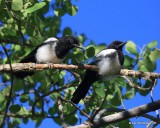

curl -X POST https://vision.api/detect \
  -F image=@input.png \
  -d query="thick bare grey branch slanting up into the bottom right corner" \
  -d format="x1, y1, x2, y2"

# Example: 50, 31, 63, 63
94, 100, 160, 127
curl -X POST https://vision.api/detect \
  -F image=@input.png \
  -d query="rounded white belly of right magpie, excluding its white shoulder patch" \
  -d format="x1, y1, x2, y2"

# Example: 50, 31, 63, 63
98, 57, 121, 80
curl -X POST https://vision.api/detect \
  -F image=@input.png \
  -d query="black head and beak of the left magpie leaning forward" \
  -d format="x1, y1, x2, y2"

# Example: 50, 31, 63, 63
64, 36, 84, 49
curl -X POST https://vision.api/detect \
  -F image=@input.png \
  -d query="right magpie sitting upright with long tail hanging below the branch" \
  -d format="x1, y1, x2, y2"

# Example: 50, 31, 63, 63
71, 41, 126, 104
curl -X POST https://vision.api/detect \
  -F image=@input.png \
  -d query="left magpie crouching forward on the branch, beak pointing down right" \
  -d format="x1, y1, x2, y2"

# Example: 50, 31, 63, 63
14, 36, 83, 79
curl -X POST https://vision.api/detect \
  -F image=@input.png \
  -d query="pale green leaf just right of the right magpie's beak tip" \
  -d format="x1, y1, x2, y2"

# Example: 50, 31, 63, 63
126, 41, 138, 55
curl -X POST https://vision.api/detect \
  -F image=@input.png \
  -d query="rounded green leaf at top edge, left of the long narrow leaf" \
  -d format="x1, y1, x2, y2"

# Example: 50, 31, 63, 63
12, 0, 23, 11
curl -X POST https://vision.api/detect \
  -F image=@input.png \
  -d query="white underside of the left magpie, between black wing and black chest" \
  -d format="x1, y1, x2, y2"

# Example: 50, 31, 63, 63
36, 40, 63, 64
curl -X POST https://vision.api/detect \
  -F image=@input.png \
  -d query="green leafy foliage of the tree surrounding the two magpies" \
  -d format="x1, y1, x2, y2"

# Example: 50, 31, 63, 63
0, 0, 160, 128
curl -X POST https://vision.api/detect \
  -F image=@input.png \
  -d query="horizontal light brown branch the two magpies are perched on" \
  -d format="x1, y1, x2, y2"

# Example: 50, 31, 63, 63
0, 63, 160, 79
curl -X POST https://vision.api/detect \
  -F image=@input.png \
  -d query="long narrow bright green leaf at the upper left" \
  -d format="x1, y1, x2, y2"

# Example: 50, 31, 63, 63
25, 2, 46, 13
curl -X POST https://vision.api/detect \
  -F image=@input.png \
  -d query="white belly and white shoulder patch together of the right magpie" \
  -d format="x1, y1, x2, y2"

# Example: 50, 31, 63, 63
97, 49, 121, 80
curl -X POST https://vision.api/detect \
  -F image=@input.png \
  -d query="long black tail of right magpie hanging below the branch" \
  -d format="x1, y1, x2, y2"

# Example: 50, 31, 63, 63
71, 70, 98, 104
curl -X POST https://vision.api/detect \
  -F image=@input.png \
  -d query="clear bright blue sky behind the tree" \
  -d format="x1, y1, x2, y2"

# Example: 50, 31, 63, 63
22, 0, 160, 128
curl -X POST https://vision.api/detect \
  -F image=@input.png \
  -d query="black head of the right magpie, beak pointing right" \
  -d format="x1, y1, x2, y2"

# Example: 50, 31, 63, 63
108, 40, 127, 51
